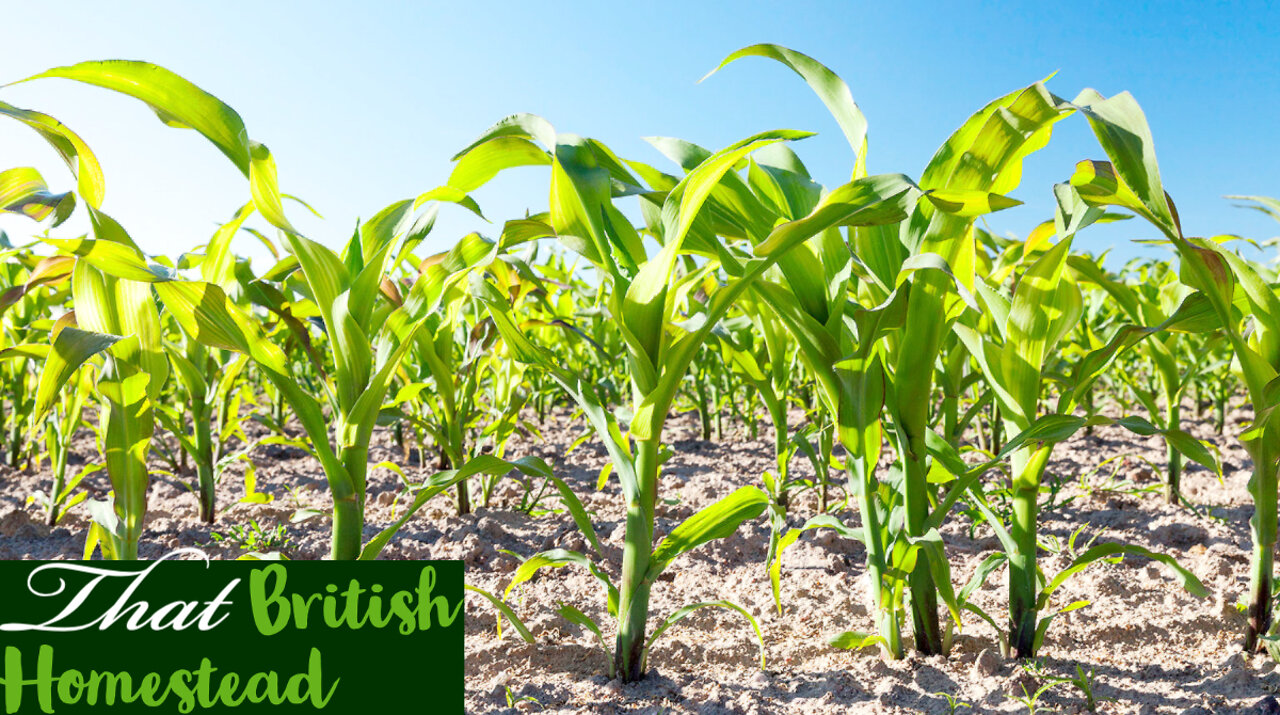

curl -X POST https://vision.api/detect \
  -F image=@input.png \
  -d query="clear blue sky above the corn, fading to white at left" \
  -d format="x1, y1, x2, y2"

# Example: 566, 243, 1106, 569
0, 0, 1280, 271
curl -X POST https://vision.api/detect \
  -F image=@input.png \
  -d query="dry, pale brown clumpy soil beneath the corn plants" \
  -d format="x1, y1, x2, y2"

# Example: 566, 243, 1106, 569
0, 411, 1280, 715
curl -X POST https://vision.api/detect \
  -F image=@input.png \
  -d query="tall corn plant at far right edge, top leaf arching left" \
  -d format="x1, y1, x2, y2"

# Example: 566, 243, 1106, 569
1071, 90, 1280, 656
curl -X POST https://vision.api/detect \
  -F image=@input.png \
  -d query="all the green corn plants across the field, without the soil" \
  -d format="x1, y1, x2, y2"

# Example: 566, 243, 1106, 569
0, 45, 1280, 680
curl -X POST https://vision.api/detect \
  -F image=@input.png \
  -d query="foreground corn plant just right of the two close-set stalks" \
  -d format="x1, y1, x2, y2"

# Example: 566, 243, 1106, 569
950, 185, 1219, 657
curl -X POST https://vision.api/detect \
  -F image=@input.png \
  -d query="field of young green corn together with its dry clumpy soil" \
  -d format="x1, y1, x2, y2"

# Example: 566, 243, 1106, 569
0, 45, 1280, 712
